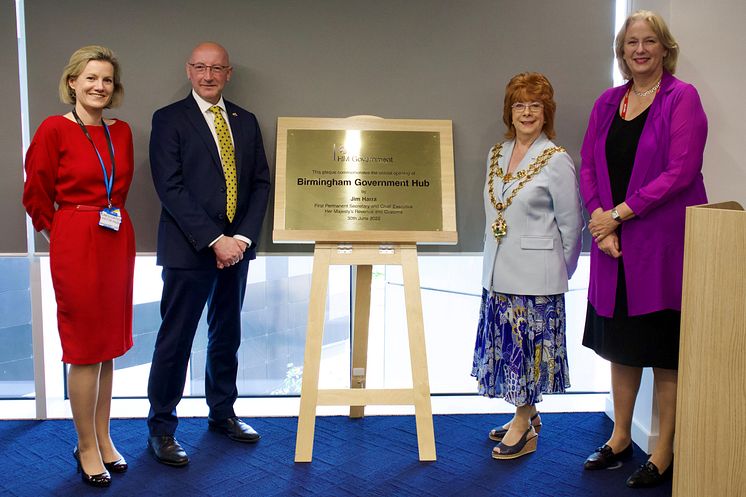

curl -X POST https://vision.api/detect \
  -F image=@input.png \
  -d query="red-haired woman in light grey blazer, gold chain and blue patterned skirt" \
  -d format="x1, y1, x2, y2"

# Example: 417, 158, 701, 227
472, 73, 583, 459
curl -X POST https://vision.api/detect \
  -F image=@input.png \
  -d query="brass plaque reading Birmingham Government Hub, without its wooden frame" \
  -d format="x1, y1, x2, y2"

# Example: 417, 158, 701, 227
285, 129, 443, 231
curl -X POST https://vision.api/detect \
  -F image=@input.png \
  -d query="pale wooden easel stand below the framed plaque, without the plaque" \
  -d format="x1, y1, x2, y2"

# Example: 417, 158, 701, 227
295, 243, 435, 462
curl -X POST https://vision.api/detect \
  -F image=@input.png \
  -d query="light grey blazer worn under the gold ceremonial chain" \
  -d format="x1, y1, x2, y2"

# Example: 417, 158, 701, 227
482, 133, 583, 295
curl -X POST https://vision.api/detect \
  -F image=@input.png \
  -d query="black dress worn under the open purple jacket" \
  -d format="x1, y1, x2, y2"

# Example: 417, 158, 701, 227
583, 107, 681, 369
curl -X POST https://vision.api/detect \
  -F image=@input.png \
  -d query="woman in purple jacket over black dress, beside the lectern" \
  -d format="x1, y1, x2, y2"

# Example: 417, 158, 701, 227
580, 11, 707, 487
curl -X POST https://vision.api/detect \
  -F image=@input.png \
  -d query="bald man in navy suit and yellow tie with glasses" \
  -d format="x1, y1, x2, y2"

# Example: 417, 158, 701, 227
148, 43, 270, 466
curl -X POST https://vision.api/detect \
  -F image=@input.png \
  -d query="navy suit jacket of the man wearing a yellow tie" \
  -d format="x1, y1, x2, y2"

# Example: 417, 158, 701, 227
150, 93, 270, 269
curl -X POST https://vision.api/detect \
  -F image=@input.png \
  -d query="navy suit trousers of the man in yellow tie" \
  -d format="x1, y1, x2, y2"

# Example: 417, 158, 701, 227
148, 259, 249, 435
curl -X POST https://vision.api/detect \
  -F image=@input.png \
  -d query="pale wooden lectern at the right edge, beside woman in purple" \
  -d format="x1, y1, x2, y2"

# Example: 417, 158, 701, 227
673, 202, 746, 497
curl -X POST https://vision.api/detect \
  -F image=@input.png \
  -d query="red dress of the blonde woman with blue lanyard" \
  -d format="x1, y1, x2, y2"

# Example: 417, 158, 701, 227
23, 116, 135, 364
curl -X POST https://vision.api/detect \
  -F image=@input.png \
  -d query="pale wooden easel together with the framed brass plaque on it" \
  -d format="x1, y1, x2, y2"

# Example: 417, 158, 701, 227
272, 116, 458, 462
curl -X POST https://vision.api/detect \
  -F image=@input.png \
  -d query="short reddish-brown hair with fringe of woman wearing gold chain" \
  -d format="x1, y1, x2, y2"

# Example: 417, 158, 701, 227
503, 72, 557, 140
